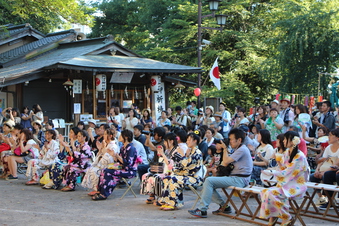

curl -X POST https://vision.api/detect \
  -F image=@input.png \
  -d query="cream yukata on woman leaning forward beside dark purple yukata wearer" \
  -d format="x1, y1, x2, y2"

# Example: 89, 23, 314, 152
81, 141, 119, 191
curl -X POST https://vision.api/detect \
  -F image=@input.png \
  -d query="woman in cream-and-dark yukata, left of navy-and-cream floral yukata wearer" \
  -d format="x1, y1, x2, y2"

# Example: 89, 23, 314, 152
141, 133, 178, 206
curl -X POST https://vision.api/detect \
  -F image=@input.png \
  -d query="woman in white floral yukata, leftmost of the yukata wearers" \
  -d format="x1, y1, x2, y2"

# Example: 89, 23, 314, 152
26, 130, 60, 185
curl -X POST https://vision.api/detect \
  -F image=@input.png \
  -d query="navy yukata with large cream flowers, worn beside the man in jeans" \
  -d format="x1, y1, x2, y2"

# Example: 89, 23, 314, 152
161, 148, 203, 208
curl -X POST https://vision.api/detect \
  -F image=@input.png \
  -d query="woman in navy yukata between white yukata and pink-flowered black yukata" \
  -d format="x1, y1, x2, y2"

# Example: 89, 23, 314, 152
42, 127, 80, 189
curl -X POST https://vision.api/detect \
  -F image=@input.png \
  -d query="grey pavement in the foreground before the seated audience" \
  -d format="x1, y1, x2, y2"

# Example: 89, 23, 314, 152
0, 174, 339, 226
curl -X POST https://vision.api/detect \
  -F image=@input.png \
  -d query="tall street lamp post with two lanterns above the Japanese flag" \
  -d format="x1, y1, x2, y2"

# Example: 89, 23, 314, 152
198, 0, 226, 108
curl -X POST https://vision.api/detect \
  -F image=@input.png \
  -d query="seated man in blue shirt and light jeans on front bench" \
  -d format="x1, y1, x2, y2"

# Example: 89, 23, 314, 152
188, 128, 253, 218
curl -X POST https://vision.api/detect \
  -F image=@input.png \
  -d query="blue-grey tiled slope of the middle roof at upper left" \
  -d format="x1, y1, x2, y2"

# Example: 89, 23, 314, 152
0, 30, 74, 64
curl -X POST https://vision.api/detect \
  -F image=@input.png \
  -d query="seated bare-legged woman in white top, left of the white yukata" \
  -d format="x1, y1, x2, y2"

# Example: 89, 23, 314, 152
6, 129, 39, 180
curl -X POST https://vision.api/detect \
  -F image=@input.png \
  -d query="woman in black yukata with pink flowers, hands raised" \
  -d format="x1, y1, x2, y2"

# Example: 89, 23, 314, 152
61, 130, 92, 191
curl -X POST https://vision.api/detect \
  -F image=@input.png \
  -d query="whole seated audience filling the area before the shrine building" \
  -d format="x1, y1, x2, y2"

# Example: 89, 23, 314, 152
0, 98, 339, 225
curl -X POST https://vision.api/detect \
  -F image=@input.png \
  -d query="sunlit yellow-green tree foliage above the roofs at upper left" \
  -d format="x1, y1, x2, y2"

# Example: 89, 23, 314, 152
0, 0, 95, 33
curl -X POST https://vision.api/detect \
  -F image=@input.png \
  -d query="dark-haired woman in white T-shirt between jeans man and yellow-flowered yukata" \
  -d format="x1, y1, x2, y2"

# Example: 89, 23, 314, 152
251, 129, 274, 184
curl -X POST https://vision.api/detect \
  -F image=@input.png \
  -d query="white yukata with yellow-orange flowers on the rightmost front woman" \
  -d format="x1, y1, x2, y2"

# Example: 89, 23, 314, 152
260, 150, 309, 220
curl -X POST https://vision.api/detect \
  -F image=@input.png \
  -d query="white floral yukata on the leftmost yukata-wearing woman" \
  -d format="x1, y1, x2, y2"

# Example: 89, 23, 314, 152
26, 140, 60, 181
